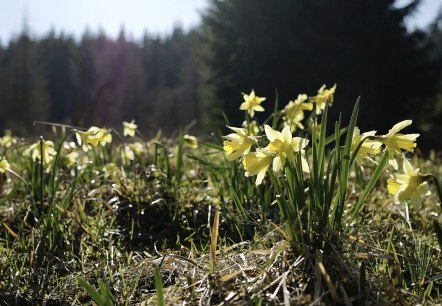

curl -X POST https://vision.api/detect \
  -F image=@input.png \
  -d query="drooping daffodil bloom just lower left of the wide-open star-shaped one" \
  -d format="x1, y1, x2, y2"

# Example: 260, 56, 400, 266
242, 149, 273, 186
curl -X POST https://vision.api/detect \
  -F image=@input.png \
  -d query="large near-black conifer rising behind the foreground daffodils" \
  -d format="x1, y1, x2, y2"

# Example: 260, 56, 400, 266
203, 0, 436, 133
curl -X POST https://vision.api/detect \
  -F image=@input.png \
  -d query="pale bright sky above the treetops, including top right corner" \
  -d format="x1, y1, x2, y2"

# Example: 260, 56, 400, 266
0, 0, 442, 44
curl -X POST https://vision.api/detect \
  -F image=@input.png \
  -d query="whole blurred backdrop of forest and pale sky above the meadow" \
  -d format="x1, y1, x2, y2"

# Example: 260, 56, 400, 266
0, 0, 442, 149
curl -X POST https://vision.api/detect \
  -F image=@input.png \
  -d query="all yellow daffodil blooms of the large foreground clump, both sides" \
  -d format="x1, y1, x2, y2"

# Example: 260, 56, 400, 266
223, 84, 429, 213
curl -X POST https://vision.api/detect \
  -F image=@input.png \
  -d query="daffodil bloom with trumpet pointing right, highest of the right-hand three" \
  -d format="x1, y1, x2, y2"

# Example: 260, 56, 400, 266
376, 120, 419, 170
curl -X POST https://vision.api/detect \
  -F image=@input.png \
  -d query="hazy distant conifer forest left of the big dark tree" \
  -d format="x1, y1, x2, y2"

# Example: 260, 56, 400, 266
0, 28, 201, 134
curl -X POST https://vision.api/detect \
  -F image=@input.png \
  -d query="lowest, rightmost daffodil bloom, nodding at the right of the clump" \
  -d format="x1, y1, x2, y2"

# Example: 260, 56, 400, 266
387, 158, 431, 210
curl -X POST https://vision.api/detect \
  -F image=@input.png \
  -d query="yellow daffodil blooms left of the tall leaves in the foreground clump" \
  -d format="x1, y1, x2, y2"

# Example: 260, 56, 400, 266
223, 85, 336, 185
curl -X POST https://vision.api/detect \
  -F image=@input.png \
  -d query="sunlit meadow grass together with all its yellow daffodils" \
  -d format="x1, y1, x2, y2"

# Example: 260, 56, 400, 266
0, 86, 442, 305
